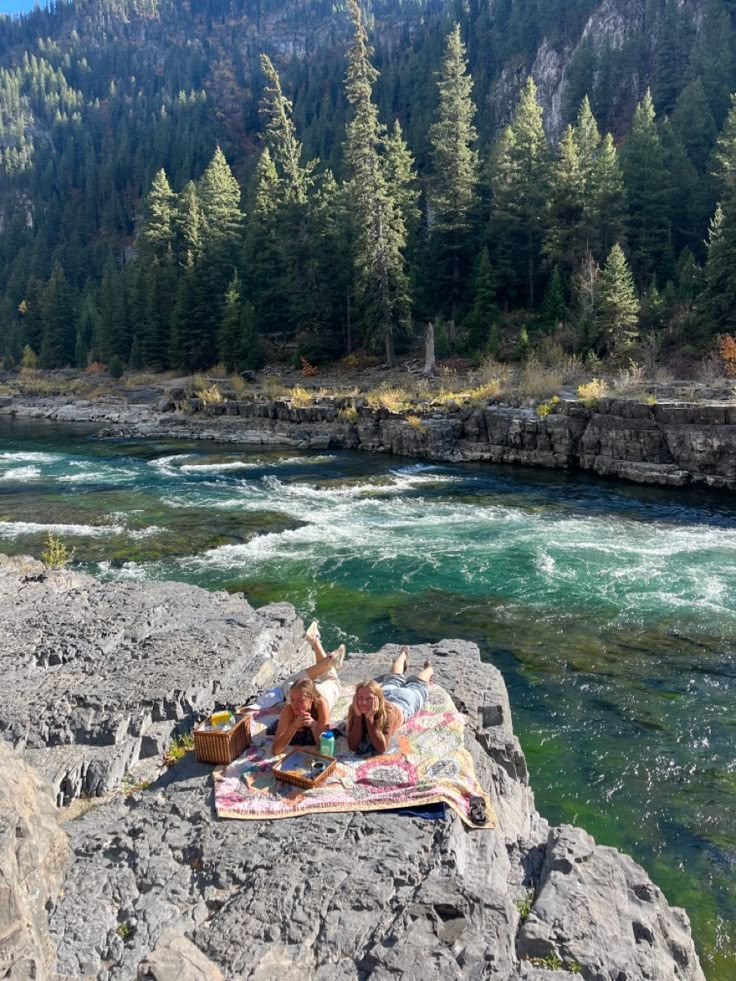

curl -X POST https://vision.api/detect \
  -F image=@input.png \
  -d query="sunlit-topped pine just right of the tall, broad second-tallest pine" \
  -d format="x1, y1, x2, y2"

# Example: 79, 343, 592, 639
491, 77, 548, 306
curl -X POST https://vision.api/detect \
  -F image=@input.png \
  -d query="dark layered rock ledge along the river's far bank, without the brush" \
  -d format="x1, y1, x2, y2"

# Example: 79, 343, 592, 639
0, 395, 736, 490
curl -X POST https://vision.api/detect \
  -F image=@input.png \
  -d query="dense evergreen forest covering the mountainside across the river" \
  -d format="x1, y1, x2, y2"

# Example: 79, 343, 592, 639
0, 0, 736, 371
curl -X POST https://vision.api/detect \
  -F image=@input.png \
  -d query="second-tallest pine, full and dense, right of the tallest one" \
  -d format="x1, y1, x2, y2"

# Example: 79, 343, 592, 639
429, 24, 478, 322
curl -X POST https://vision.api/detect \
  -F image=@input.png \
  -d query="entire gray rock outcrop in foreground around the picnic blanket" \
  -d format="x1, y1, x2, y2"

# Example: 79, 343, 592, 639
0, 560, 703, 981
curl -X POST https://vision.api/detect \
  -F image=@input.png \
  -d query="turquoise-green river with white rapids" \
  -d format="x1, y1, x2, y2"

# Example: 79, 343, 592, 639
0, 420, 736, 981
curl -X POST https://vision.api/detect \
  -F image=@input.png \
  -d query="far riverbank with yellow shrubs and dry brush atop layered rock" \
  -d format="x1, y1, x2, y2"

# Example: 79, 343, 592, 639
0, 358, 736, 490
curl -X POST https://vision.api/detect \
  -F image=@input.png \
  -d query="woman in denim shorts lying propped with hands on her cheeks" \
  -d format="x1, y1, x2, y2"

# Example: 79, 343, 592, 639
348, 647, 434, 754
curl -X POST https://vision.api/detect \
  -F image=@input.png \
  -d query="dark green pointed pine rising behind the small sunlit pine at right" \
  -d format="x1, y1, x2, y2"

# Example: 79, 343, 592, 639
621, 89, 671, 283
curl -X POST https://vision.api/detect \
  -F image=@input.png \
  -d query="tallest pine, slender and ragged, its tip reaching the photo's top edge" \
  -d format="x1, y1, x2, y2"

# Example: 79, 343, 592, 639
345, 0, 410, 364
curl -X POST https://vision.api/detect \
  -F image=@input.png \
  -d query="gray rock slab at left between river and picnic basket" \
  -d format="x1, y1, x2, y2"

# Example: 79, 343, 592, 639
0, 556, 312, 802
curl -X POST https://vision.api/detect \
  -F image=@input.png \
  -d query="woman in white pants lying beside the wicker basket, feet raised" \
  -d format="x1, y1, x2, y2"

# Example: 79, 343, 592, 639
273, 622, 345, 756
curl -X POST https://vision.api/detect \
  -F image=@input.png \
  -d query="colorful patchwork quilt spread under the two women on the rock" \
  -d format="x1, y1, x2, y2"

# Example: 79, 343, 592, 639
214, 684, 496, 828
